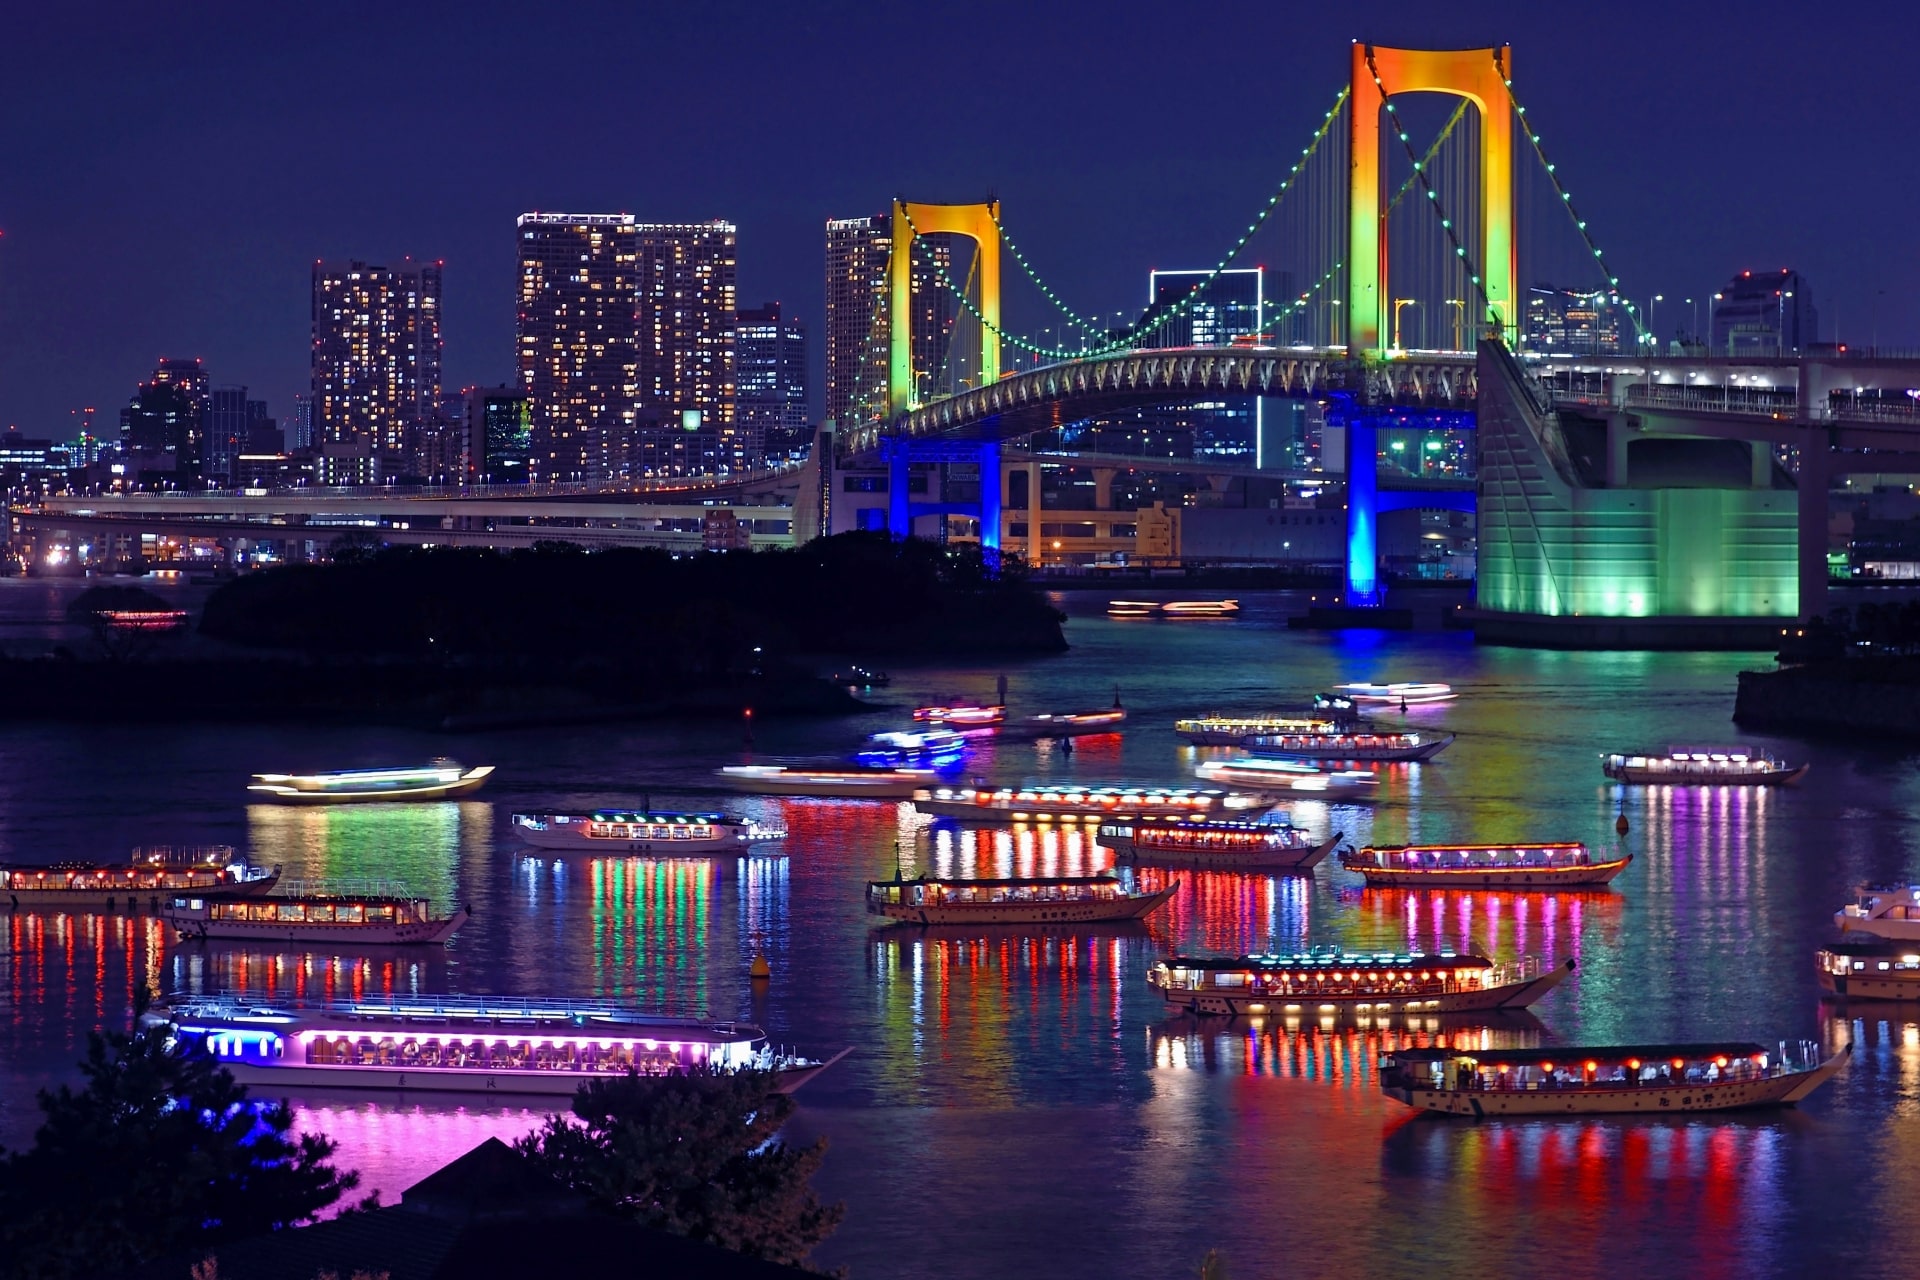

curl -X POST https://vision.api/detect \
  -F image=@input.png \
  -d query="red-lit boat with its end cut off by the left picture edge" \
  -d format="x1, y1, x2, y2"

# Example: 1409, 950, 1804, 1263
0, 844, 280, 912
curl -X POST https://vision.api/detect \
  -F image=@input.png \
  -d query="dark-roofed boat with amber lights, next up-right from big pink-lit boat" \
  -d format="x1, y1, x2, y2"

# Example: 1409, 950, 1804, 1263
866, 875, 1181, 925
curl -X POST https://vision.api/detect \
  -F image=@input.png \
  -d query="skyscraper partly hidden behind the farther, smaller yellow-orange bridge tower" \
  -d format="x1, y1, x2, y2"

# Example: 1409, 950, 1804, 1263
826, 213, 956, 426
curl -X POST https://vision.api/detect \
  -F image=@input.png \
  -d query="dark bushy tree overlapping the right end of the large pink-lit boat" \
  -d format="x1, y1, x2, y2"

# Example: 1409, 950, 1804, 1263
516, 1071, 845, 1267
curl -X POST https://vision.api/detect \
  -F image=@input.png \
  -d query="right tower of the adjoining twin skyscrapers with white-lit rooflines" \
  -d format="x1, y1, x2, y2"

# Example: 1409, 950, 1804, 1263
628, 219, 753, 476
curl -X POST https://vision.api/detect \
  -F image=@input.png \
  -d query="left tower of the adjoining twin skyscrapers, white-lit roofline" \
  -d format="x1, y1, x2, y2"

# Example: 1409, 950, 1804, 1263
516, 213, 639, 482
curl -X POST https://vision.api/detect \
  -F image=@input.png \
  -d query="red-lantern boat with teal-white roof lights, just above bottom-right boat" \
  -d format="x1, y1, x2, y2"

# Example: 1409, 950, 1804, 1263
1146, 948, 1572, 1015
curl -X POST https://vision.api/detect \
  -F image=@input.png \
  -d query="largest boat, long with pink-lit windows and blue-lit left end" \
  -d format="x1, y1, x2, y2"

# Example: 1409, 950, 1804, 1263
148, 996, 839, 1096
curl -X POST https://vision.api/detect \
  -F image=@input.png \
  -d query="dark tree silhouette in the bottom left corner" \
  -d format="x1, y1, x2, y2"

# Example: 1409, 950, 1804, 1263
0, 1002, 359, 1280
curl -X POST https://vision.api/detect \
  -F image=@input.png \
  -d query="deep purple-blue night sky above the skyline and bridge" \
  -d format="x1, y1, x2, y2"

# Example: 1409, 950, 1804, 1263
0, 0, 1920, 436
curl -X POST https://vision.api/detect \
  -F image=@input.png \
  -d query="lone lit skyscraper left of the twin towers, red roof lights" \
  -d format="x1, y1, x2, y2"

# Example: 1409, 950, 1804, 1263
313, 259, 442, 455
